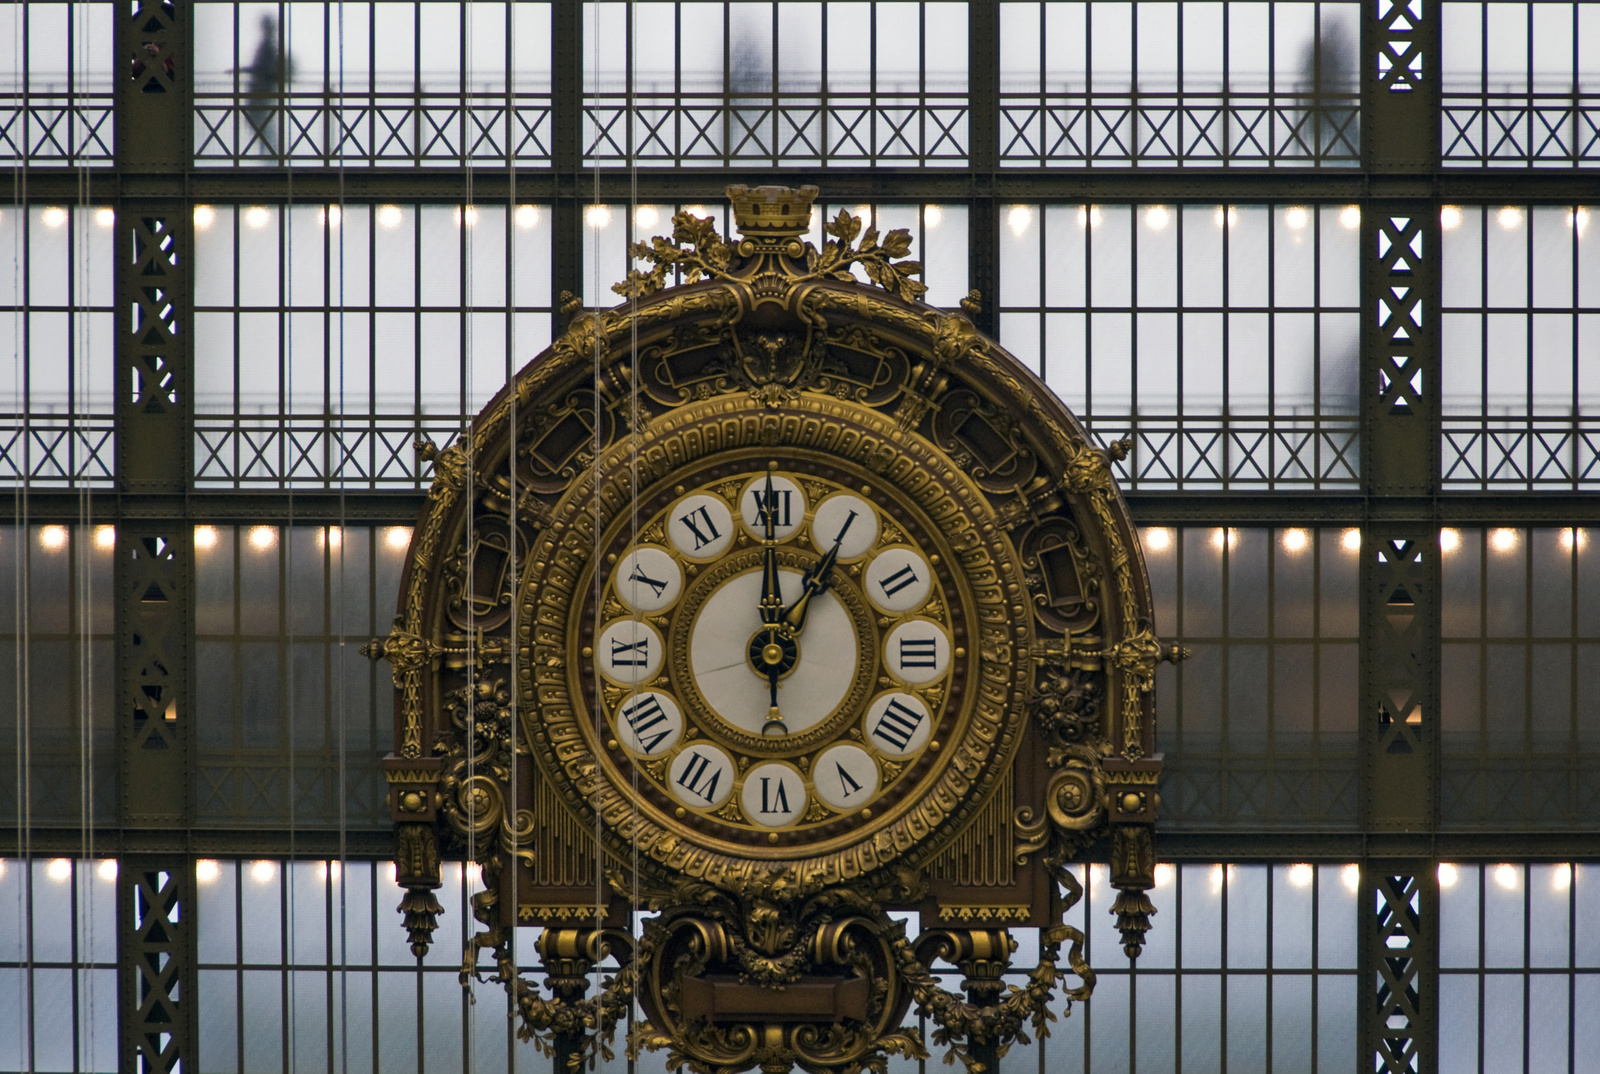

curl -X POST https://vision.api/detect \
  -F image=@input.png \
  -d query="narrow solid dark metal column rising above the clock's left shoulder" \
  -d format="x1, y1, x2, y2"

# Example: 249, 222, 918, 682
550, 0, 585, 335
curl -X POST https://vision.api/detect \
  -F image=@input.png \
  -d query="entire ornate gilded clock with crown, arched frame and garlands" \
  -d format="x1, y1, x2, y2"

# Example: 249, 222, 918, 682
371, 187, 1179, 1071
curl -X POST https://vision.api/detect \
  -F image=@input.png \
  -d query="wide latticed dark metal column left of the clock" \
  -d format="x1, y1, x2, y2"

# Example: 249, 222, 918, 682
114, 0, 197, 1074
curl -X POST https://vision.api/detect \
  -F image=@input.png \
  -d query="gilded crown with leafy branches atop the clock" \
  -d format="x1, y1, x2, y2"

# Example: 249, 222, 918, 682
611, 182, 928, 303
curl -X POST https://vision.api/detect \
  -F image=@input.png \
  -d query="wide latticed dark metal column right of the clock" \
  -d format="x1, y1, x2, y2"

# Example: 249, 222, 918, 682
1357, 0, 1440, 1074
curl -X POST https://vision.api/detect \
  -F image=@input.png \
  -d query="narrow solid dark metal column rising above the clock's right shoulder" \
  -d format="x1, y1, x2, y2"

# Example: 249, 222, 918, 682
966, 0, 1000, 338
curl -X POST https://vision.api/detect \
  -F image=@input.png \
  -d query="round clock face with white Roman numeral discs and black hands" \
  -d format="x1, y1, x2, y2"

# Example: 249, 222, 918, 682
584, 453, 970, 845
